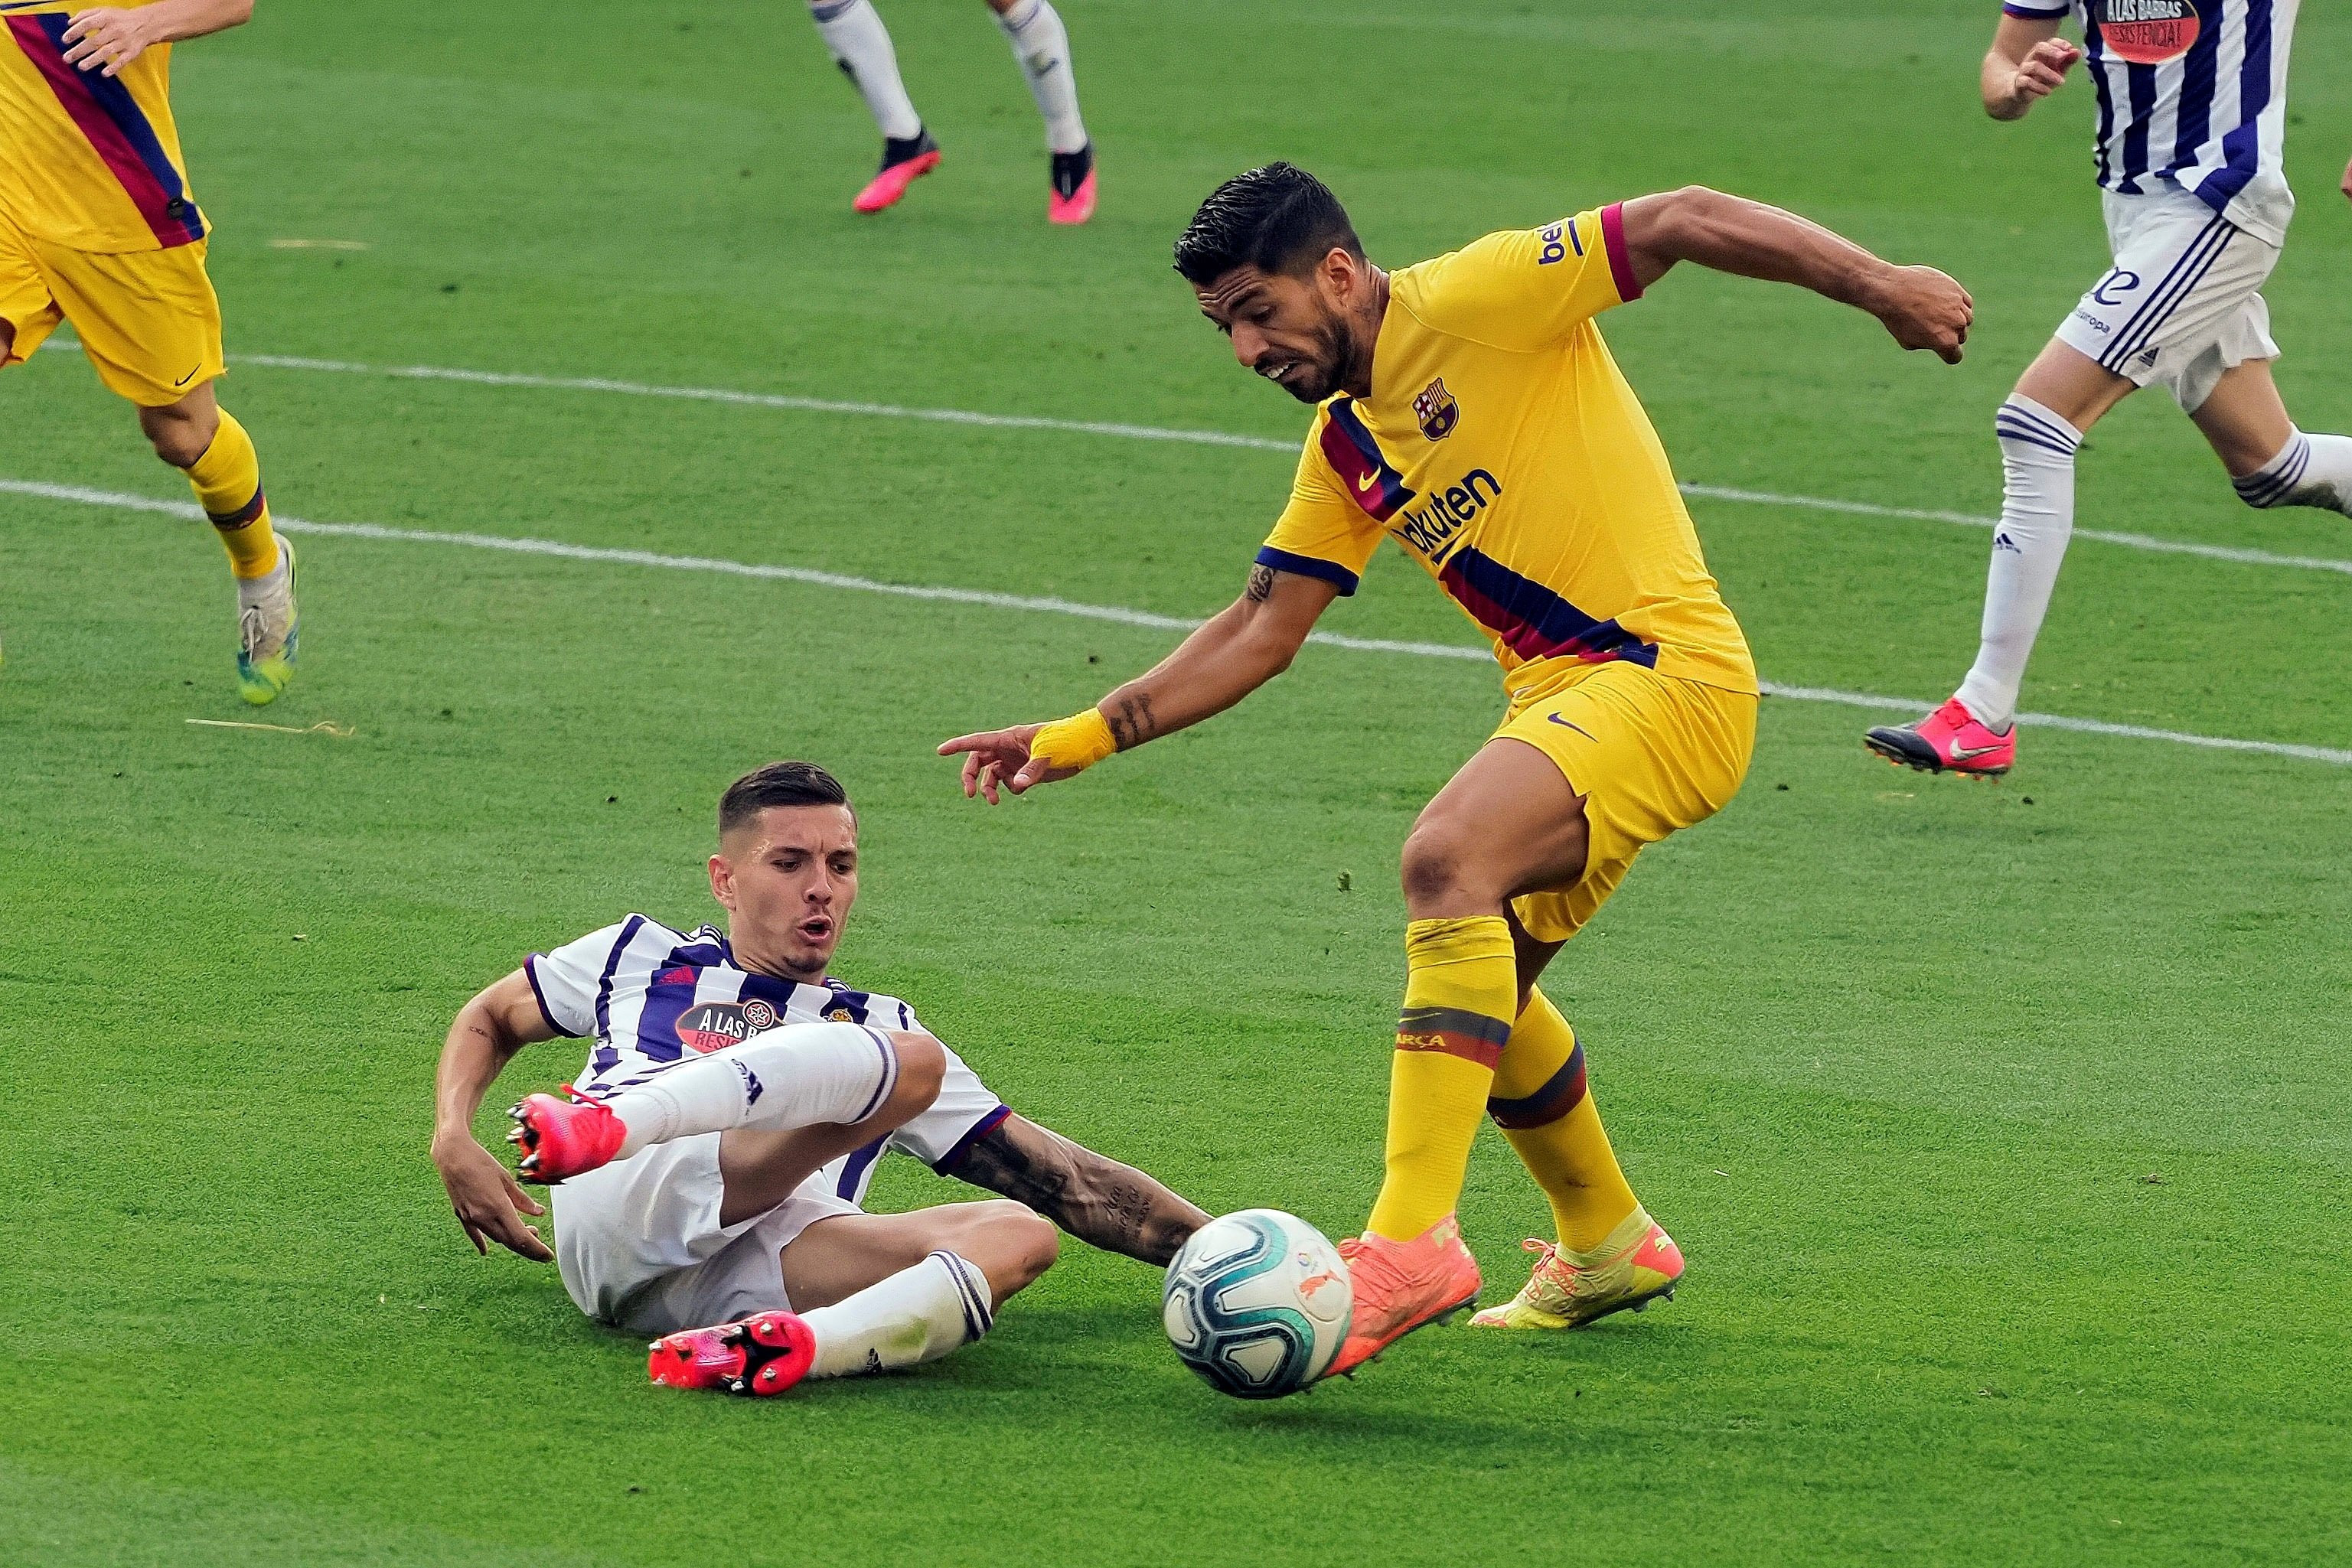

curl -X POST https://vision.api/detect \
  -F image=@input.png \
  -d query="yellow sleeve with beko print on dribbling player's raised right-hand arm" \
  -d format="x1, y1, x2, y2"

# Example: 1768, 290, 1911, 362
1397, 204, 1642, 350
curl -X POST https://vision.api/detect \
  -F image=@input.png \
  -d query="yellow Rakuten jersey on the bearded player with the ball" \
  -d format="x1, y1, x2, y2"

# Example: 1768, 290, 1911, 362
1258, 207, 1757, 700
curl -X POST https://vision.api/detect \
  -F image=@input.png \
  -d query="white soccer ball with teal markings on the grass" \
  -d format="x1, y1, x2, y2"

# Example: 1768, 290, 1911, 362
1160, 1208, 1355, 1399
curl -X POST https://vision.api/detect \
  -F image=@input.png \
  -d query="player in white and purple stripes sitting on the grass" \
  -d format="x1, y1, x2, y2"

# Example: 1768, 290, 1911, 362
432, 761, 1206, 1394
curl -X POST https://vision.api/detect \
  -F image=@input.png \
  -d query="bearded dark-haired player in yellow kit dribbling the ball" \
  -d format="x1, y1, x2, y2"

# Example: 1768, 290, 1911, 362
938, 162, 1971, 1373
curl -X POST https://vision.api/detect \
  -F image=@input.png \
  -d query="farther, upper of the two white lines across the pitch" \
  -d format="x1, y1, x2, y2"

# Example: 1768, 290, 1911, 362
42, 338, 2352, 576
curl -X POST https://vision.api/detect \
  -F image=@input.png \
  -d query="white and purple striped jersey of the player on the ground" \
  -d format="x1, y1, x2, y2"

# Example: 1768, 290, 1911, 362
522, 914, 1011, 1204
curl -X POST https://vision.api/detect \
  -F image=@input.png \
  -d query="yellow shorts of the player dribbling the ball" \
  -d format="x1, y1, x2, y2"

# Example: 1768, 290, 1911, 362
1493, 663, 1757, 943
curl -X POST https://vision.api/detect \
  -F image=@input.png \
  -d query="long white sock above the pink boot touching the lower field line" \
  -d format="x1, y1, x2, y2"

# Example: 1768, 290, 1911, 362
1957, 393, 2082, 731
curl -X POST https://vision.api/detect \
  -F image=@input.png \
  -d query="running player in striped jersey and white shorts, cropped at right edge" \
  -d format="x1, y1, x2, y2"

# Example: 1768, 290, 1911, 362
1863, 0, 2352, 776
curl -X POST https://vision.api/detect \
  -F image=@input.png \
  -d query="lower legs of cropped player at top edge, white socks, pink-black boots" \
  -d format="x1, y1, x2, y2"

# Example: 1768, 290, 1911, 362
809, 0, 1094, 223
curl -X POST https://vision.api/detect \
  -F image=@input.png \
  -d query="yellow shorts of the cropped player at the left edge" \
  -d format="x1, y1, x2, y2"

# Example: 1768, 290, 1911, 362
0, 217, 221, 409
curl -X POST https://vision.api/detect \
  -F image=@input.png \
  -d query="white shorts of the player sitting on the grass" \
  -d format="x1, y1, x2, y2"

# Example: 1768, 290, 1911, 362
550, 1133, 863, 1333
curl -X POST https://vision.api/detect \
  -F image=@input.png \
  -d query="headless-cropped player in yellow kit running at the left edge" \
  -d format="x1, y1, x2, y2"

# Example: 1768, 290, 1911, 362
0, 0, 298, 703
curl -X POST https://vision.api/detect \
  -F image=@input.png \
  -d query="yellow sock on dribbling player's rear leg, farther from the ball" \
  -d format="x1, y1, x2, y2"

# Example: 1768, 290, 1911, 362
1486, 989, 1639, 1253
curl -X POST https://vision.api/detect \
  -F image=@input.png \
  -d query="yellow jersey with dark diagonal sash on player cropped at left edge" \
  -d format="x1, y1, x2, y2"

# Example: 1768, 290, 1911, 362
0, 0, 204, 252
